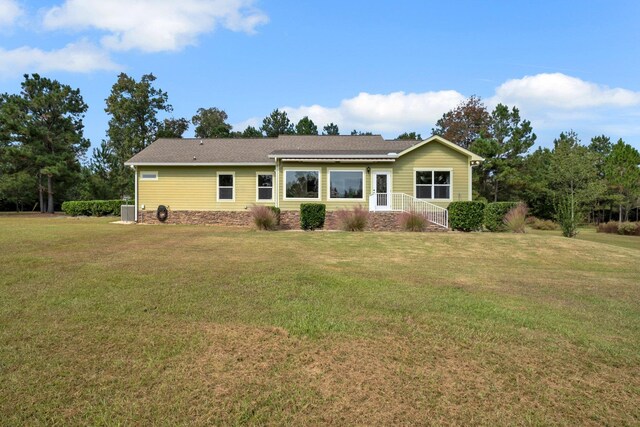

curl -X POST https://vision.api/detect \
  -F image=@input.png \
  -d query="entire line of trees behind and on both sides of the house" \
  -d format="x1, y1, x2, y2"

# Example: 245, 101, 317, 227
0, 73, 640, 221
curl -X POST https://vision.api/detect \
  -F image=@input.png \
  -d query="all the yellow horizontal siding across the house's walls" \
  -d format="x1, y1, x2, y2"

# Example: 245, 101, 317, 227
138, 141, 470, 210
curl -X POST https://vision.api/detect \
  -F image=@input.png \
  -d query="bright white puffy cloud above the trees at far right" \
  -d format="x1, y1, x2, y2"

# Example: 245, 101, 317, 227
490, 73, 640, 110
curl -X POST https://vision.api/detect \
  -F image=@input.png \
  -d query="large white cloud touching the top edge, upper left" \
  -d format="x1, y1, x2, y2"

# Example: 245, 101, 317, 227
44, 0, 269, 52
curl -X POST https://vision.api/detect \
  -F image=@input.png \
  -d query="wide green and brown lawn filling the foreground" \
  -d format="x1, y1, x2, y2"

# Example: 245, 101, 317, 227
0, 215, 640, 425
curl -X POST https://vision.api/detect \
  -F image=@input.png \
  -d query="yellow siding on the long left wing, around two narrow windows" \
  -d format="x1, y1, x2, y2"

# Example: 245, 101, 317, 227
138, 166, 275, 210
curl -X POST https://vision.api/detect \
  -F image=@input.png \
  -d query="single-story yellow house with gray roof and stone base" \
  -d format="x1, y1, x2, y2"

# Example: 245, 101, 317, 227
126, 135, 483, 228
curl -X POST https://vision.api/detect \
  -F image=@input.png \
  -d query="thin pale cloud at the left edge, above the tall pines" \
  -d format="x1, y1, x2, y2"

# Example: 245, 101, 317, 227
0, 40, 119, 76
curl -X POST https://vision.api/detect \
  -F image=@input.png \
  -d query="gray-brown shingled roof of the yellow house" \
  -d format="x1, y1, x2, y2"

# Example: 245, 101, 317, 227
126, 135, 419, 165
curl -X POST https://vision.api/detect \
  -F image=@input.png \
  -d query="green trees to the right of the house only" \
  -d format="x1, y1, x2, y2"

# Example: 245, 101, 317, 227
432, 96, 640, 223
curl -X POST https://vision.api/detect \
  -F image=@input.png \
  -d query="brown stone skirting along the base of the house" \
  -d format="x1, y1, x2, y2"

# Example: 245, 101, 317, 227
138, 211, 447, 231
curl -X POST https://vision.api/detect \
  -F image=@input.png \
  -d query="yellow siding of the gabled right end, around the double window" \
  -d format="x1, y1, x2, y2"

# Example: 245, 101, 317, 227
393, 141, 469, 208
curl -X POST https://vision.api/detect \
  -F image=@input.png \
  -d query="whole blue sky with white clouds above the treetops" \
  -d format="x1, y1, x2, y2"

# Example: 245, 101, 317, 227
0, 0, 640, 149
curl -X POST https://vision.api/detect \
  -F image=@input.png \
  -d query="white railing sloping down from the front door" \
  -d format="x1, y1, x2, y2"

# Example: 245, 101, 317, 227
369, 193, 449, 228
